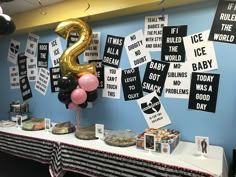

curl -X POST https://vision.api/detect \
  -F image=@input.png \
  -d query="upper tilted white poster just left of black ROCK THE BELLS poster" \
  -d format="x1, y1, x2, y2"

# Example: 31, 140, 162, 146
25, 33, 39, 58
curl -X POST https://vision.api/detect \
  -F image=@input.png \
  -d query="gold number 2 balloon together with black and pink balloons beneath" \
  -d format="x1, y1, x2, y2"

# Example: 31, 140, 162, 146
55, 19, 99, 110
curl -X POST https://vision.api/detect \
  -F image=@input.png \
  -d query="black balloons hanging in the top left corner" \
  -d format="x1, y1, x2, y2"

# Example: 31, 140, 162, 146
0, 6, 16, 35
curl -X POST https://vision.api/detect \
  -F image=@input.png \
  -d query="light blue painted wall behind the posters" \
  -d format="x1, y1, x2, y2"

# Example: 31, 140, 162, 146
0, 0, 236, 165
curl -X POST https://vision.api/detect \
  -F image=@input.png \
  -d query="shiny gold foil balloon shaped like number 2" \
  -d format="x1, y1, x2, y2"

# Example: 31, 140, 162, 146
55, 19, 96, 76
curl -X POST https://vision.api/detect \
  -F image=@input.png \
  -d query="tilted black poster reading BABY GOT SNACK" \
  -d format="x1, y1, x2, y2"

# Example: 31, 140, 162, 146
142, 60, 170, 96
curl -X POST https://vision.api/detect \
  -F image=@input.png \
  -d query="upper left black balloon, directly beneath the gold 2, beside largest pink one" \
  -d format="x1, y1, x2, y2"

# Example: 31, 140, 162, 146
58, 75, 78, 92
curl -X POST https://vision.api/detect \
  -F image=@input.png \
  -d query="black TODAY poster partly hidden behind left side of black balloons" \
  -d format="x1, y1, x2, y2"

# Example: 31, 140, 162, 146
49, 67, 61, 92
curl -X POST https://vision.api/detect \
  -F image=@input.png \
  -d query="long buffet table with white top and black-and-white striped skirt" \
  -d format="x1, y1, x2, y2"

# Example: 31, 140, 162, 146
0, 127, 228, 177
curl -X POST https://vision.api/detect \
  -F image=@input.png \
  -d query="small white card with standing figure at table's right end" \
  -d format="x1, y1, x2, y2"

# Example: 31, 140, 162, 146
195, 136, 209, 154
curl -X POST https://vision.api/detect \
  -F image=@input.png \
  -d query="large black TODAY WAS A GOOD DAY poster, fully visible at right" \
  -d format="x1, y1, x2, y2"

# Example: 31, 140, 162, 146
188, 72, 220, 112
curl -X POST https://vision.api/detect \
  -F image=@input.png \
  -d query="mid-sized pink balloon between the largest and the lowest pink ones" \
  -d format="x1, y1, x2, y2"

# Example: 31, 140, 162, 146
70, 88, 87, 104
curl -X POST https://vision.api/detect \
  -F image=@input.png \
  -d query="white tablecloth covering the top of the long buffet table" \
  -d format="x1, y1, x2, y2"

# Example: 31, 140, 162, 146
0, 127, 228, 177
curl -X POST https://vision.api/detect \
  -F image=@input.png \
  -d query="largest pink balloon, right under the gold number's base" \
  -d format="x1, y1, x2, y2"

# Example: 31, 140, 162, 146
78, 74, 99, 92
